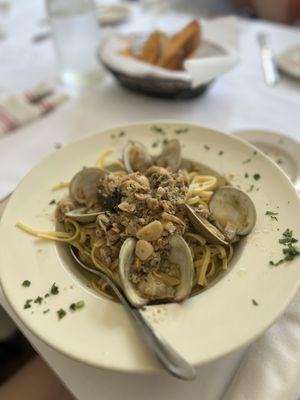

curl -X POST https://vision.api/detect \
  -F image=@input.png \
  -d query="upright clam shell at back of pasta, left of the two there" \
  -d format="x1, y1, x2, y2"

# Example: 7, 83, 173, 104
123, 142, 153, 173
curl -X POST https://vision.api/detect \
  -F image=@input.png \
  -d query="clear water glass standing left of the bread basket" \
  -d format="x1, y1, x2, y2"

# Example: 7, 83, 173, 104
46, 0, 103, 87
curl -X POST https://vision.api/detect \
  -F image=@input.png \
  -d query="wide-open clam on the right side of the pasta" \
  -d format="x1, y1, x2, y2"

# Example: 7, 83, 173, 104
185, 186, 256, 245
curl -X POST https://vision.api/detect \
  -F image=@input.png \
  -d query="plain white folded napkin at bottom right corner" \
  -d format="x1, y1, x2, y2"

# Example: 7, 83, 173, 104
223, 292, 300, 400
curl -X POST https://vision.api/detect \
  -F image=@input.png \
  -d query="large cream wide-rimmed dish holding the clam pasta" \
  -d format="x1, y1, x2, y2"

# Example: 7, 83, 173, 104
0, 122, 300, 373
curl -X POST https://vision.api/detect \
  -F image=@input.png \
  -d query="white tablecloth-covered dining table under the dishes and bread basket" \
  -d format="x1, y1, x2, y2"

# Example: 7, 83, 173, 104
0, 0, 300, 400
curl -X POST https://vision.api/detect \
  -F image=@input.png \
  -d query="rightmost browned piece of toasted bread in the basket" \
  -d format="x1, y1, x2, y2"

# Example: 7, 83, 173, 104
156, 20, 201, 70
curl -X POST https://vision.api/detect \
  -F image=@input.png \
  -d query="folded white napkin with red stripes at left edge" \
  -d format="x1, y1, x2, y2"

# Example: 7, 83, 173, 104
0, 83, 68, 136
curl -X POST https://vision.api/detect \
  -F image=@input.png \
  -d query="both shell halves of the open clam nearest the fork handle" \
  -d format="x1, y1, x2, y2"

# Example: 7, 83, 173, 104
119, 235, 194, 307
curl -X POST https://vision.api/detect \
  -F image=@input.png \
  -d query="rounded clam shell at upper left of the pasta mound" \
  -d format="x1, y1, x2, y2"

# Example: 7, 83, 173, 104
69, 168, 107, 206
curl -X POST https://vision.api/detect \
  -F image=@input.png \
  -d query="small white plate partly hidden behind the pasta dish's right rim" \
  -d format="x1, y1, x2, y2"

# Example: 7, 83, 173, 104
232, 129, 300, 192
